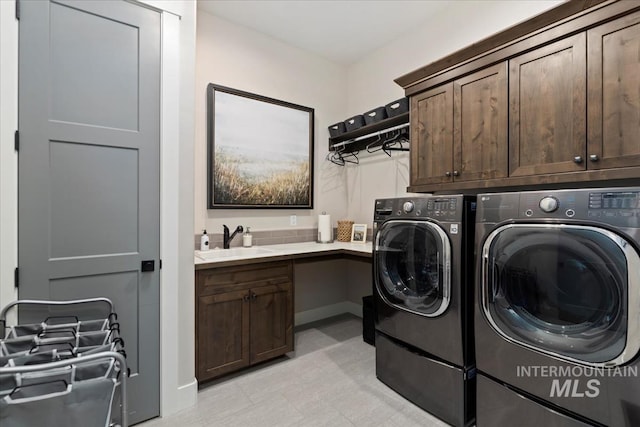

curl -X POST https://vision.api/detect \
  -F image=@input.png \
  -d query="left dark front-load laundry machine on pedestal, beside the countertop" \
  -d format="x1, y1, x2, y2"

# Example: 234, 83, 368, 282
373, 195, 475, 426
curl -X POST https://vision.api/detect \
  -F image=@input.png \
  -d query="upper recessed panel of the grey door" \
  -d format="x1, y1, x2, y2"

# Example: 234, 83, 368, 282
50, 2, 140, 130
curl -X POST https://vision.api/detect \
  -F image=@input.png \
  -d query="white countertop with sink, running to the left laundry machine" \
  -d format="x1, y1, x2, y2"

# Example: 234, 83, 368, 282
194, 242, 373, 265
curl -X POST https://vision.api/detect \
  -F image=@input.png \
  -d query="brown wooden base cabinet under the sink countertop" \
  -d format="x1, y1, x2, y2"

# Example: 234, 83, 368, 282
196, 261, 293, 381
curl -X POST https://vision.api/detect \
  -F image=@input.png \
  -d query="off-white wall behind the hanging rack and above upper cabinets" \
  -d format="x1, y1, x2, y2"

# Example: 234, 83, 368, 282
345, 0, 562, 224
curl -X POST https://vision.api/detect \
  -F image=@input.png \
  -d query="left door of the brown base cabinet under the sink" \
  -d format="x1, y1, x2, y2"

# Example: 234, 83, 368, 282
197, 290, 250, 381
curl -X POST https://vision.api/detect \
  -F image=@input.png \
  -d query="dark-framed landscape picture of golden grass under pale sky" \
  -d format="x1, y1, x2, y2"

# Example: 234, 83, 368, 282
207, 83, 314, 209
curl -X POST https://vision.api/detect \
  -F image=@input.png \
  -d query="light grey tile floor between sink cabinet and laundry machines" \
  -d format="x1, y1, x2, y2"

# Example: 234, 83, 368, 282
139, 315, 447, 427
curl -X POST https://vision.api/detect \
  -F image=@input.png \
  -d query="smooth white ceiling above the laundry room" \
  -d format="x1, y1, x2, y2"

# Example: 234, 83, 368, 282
198, 0, 450, 65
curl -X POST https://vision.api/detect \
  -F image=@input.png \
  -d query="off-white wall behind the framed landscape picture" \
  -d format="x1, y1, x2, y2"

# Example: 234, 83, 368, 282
194, 10, 347, 237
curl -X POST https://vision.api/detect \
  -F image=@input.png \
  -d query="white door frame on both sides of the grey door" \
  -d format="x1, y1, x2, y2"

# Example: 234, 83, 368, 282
0, 0, 198, 422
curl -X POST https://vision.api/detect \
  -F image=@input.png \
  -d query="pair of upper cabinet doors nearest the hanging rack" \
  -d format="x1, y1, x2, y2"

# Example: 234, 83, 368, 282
411, 63, 508, 185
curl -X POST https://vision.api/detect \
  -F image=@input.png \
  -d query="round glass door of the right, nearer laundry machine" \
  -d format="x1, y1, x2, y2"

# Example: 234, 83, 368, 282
480, 224, 640, 366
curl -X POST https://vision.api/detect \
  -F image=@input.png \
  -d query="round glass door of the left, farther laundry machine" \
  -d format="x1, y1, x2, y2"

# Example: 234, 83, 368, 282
373, 220, 451, 317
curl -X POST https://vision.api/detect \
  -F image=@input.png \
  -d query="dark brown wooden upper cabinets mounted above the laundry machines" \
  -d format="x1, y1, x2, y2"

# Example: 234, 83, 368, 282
396, 0, 640, 192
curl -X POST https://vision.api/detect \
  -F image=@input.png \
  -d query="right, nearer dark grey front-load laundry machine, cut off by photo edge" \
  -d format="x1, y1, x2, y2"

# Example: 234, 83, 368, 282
475, 187, 640, 427
